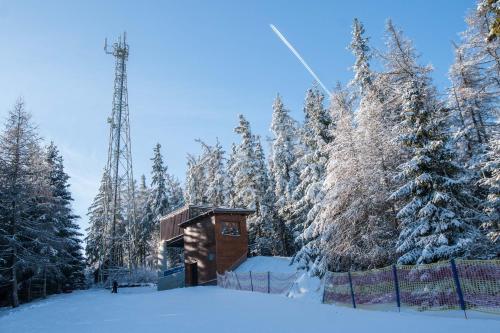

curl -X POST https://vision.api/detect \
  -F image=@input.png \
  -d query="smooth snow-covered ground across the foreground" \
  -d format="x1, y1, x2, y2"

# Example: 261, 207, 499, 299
0, 287, 500, 333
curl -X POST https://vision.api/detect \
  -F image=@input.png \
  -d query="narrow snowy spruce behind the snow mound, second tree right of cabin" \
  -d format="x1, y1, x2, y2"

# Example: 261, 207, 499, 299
269, 95, 299, 256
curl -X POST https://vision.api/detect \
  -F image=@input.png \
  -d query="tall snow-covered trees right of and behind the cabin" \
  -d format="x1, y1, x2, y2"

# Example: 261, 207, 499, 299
185, 6, 500, 274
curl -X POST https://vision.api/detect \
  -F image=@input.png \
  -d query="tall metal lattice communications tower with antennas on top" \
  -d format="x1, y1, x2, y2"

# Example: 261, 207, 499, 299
104, 32, 136, 269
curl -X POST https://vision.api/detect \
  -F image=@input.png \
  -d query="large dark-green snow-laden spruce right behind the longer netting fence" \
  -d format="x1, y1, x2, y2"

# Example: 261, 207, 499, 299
391, 75, 487, 264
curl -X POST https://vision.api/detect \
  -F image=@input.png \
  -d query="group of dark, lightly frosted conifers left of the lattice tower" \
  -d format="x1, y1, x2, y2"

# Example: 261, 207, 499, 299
0, 99, 85, 307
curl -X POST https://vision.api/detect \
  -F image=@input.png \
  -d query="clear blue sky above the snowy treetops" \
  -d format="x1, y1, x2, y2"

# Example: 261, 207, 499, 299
0, 0, 475, 233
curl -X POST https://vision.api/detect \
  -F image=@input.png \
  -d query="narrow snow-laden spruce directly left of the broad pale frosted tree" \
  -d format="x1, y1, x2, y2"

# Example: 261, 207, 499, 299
289, 89, 333, 260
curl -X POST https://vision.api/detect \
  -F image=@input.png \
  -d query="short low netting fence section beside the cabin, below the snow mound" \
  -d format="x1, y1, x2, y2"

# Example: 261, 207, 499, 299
217, 271, 298, 294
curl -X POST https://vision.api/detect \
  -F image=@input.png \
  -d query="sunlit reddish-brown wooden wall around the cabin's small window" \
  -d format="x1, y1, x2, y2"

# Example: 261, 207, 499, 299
214, 214, 248, 274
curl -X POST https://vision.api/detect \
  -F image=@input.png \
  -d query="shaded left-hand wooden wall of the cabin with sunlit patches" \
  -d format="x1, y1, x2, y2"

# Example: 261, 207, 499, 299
184, 216, 217, 285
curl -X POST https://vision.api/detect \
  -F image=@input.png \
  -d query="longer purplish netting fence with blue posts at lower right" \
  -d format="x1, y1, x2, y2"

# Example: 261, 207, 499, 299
323, 260, 500, 314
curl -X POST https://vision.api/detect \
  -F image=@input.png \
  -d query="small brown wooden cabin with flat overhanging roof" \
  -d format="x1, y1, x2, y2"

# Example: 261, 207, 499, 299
160, 205, 254, 286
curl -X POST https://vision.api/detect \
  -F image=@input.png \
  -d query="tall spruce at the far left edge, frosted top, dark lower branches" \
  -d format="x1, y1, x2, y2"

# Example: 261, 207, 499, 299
0, 99, 46, 307
